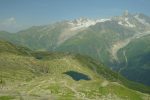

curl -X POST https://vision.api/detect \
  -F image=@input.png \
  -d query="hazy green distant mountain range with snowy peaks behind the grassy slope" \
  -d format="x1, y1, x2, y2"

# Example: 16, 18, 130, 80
0, 11, 150, 86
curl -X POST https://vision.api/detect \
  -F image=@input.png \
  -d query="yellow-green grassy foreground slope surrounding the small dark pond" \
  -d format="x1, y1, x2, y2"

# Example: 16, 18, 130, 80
0, 41, 148, 100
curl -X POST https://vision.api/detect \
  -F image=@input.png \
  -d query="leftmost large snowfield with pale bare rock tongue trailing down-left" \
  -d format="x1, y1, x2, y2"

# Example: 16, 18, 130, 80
57, 18, 111, 46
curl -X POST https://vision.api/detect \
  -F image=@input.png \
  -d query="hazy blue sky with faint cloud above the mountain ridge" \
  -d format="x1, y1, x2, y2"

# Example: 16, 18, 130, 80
0, 0, 150, 32
